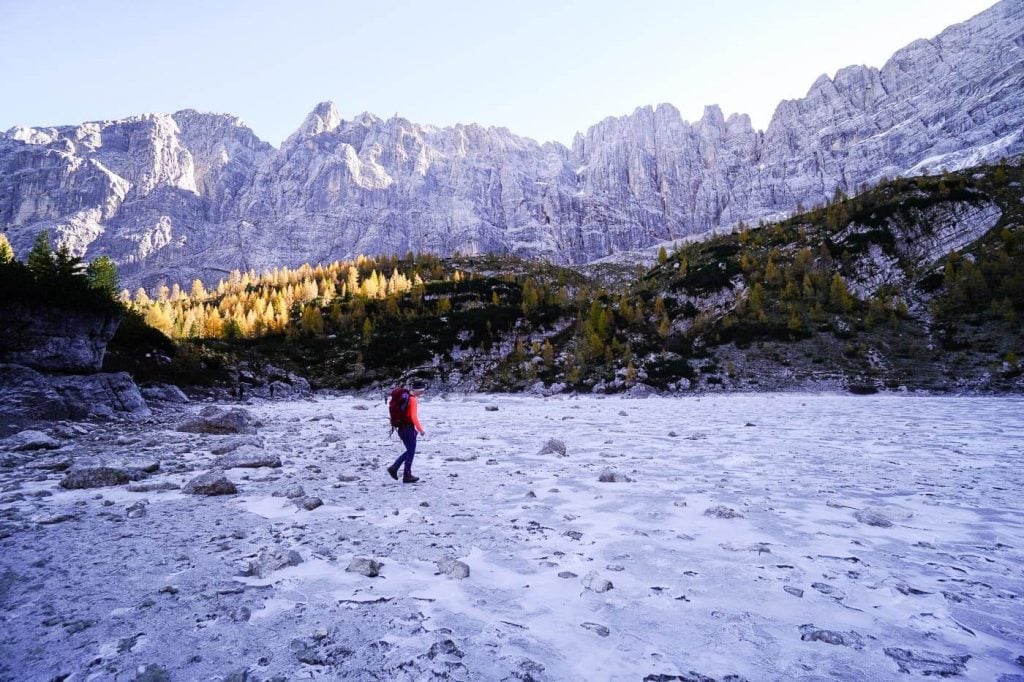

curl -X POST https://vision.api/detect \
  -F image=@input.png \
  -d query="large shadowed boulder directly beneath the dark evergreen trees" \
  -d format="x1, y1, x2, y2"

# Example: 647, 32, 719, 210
0, 304, 121, 372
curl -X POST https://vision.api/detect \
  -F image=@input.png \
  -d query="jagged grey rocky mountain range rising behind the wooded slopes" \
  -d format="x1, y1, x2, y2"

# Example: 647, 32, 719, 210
0, 0, 1024, 285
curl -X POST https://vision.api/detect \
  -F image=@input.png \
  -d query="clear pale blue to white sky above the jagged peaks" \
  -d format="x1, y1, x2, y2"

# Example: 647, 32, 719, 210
0, 0, 992, 145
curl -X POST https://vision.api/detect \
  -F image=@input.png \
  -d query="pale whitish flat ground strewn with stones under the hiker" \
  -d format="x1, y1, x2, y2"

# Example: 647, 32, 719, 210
0, 394, 1024, 680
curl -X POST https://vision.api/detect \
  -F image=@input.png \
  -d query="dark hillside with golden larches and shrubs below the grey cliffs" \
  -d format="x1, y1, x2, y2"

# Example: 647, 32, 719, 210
108, 157, 1024, 392
